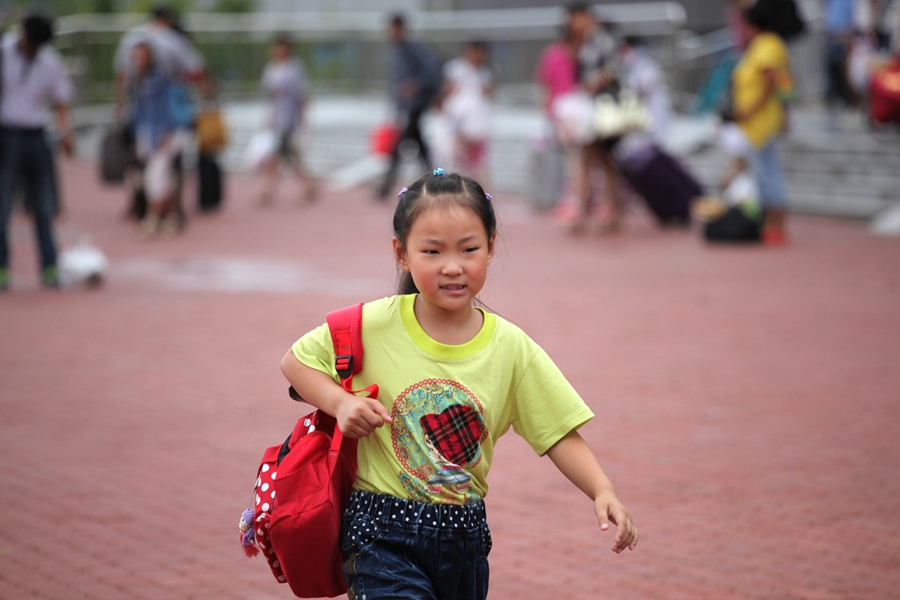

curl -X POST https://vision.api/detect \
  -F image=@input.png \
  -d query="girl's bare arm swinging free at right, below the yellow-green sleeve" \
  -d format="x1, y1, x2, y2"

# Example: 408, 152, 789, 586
547, 430, 638, 554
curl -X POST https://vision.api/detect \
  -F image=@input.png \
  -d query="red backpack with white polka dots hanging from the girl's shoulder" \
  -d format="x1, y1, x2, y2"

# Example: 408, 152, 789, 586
240, 304, 378, 598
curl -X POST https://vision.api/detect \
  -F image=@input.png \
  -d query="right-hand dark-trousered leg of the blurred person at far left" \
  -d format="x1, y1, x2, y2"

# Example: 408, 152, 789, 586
22, 133, 57, 286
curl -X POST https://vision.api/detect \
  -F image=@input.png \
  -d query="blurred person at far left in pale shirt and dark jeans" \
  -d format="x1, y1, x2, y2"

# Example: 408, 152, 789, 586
0, 14, 74, 290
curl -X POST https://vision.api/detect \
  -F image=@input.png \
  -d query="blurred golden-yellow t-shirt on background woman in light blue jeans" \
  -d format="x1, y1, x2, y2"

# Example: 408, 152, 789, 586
732, 32, 790, 148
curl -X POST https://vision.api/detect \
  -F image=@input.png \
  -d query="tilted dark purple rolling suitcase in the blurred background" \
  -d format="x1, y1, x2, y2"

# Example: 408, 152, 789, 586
613, 138, 703, 225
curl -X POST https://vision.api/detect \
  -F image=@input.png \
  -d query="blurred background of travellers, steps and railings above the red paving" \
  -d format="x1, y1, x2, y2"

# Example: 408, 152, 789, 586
0, 0, 900, 288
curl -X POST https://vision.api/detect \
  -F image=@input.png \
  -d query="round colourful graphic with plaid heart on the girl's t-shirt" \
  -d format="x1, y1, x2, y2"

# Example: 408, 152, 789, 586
391, 379, 488, 504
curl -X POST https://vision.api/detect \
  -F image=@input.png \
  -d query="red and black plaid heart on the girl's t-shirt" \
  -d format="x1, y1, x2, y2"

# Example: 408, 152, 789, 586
419, 404, 485, 467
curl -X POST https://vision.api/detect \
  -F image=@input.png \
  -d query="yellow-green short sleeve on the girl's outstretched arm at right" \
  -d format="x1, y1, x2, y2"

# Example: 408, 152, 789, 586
512, 348, 594, 456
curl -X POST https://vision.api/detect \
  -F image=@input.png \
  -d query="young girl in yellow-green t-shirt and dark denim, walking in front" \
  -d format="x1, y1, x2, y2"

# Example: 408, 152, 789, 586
281, 169, 638, 600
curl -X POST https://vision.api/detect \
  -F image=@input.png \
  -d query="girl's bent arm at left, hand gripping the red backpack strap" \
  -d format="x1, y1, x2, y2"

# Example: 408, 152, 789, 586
281, 350, 391, 438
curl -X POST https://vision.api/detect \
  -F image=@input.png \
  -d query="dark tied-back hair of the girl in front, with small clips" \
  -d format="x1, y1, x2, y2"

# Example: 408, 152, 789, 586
394, 173, 497, 294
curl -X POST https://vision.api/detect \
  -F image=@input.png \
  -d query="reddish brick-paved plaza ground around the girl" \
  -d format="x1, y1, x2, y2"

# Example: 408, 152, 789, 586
0, 163, 900, 600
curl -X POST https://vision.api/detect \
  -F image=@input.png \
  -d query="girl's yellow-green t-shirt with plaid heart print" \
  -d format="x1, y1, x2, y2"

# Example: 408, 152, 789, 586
292, 295, 594, 504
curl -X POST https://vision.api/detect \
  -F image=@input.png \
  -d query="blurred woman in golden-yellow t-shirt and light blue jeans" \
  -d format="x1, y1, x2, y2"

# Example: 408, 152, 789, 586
732, 3, 790, 245
